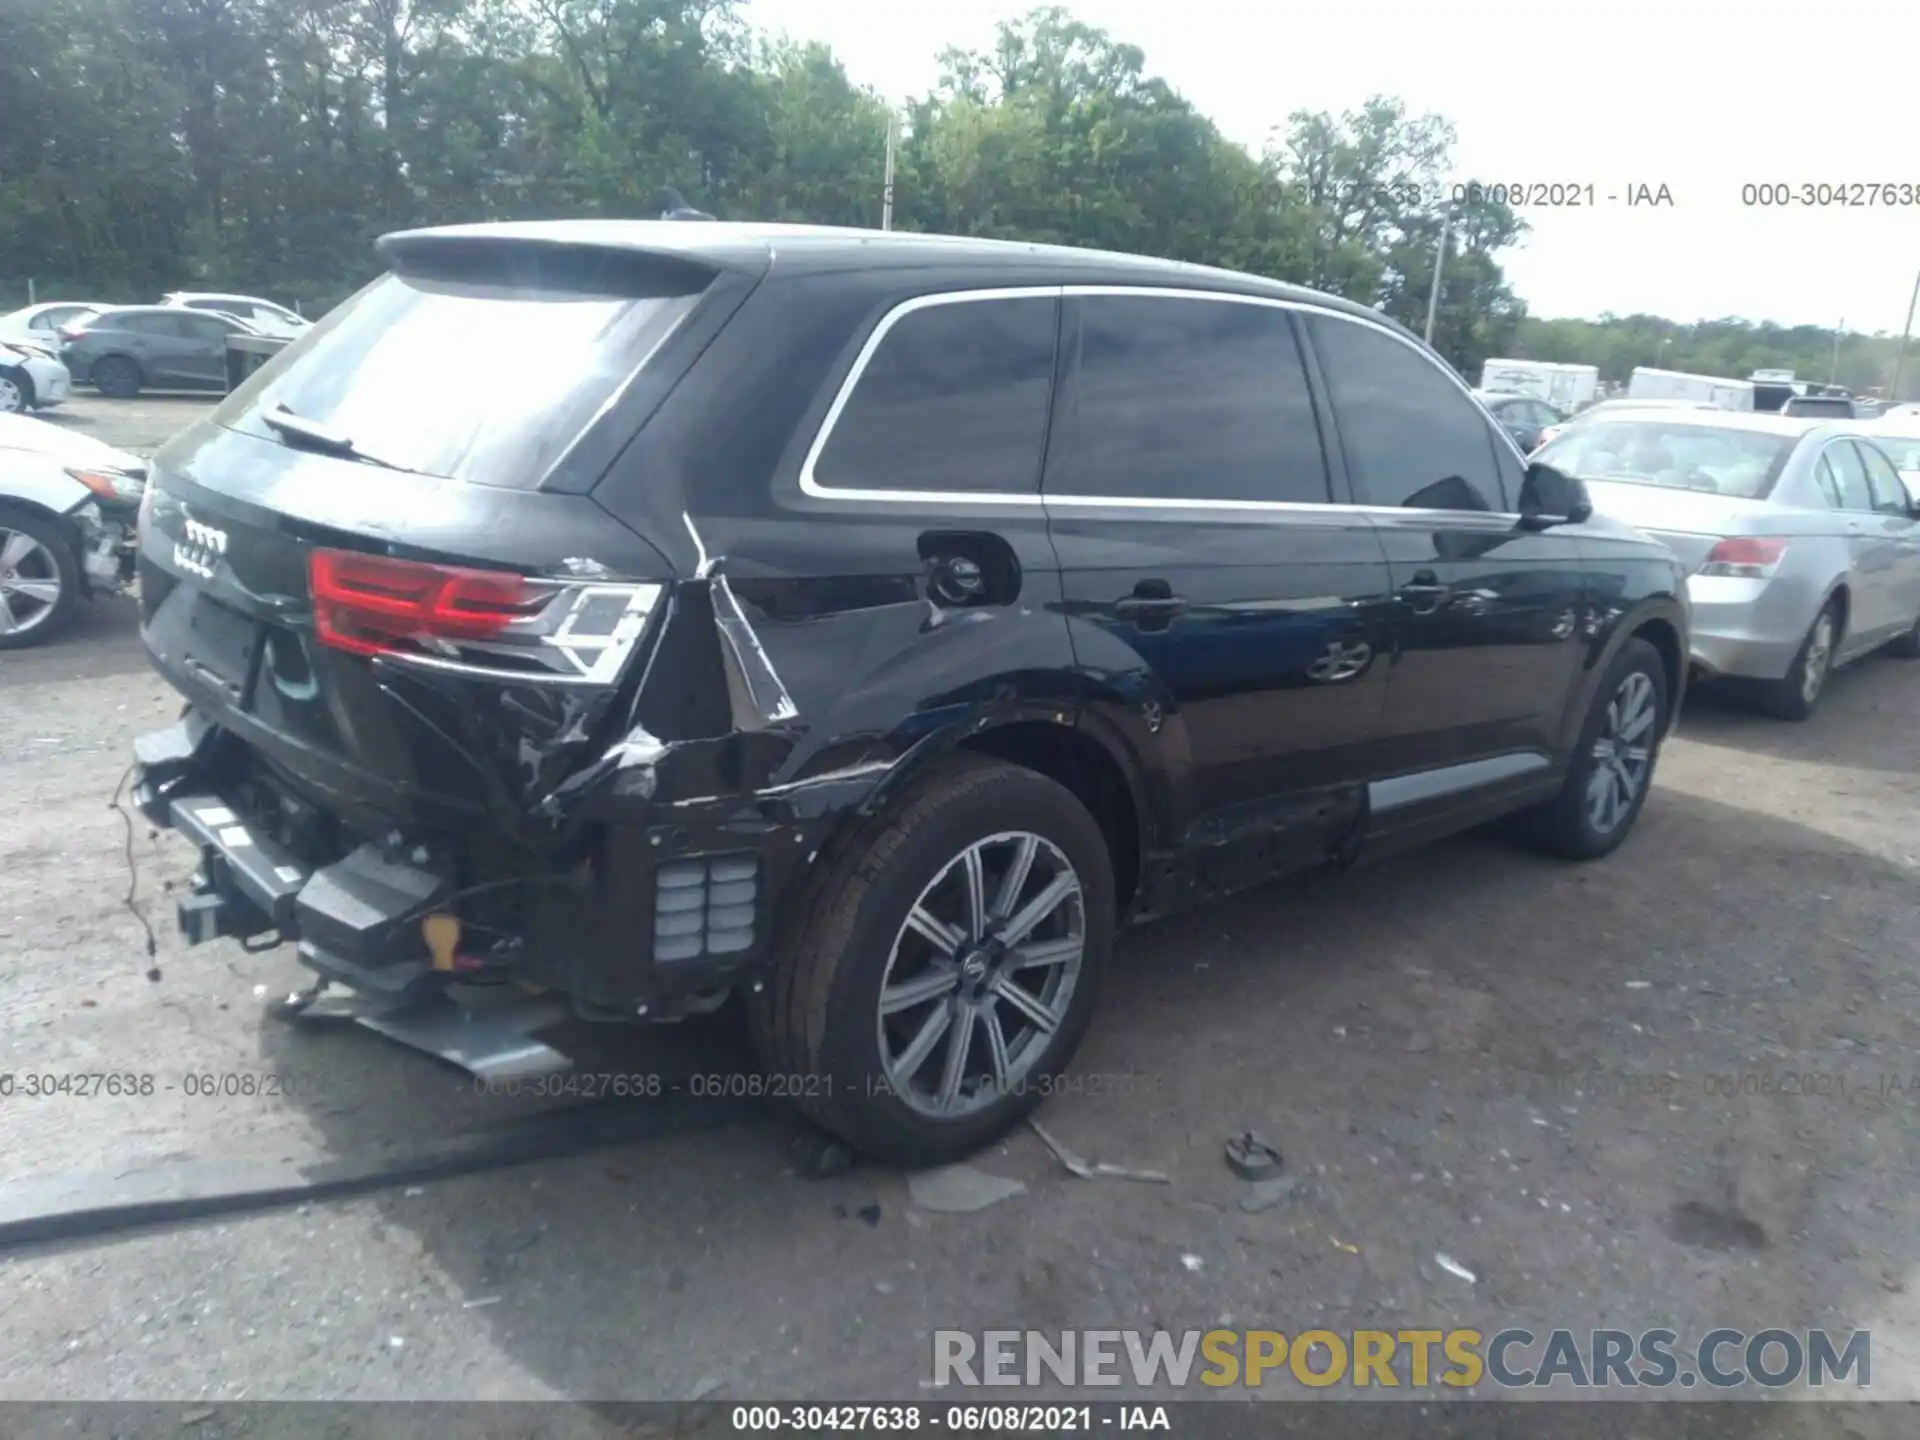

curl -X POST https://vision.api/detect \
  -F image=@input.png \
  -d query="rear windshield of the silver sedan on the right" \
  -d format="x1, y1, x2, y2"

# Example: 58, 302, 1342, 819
1534, 420, 1795, 499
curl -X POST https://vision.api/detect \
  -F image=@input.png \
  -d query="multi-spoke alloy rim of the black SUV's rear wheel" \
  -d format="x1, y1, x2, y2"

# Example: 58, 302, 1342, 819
877, 831, 1087, 1119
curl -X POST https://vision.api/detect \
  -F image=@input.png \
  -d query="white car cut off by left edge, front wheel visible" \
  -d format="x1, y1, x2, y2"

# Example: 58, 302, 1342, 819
0, 415, 146, 651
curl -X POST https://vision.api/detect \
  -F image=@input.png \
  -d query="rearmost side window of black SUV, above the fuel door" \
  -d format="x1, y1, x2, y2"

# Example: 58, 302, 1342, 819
814, 296, 1060, 495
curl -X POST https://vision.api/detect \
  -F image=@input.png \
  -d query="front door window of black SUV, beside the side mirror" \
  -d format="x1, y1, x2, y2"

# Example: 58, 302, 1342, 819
1311, 315, 1507, 511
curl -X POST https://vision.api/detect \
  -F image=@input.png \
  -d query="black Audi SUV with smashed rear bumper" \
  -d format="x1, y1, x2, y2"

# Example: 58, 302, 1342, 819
136, 221, 1688, 1162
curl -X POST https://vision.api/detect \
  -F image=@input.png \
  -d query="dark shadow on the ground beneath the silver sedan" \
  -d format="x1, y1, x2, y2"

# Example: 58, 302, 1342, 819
1680, 655, 1920, 774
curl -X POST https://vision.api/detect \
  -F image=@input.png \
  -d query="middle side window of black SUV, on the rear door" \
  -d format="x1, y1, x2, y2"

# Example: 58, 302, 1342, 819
1046, 296, 1329, 505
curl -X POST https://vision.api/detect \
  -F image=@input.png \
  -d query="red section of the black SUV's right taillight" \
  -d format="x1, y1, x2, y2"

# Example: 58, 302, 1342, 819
307, 549, 549, 655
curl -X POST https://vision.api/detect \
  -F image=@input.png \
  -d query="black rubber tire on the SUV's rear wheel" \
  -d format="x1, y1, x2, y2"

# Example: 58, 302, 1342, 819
749, 756, 1114, 1165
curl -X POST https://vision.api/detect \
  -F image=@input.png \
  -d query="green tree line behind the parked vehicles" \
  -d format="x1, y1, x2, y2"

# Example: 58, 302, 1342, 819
0, 0, 1889, 395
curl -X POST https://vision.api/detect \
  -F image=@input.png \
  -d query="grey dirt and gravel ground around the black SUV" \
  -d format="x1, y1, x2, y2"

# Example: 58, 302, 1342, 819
0, 391, 1920, 1434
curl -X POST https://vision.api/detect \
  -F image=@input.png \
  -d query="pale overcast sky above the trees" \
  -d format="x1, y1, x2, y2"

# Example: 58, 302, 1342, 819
745, 0, 1920, 334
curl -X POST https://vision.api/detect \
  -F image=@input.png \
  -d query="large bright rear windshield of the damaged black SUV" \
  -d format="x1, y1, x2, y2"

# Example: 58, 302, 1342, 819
213, 264, 699, 490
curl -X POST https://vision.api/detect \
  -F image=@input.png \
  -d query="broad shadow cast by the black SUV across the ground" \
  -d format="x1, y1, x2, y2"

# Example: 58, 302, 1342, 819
228, 768, 1920, 1413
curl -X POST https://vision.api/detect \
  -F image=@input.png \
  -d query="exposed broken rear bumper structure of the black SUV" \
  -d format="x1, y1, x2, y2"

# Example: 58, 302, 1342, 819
132, 710, 810, 1020
